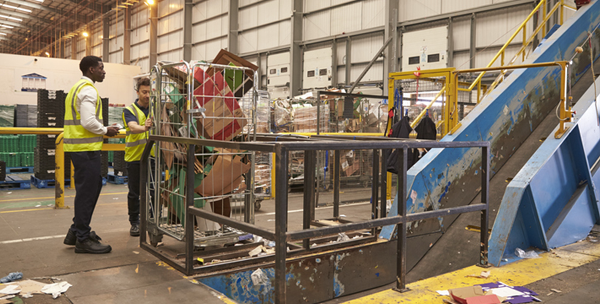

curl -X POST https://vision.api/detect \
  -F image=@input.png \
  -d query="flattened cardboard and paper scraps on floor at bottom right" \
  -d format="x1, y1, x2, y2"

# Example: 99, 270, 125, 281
437, 282, 540, 304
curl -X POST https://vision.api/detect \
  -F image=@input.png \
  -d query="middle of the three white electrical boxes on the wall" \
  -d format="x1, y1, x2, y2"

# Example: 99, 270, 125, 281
302, 48, 332, 89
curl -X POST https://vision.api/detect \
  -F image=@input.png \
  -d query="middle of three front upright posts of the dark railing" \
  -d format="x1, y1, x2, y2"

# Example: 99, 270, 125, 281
394, 148, 409, 292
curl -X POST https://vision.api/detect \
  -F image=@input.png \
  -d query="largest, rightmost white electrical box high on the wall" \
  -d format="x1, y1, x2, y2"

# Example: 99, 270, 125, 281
402, 26, 448, 71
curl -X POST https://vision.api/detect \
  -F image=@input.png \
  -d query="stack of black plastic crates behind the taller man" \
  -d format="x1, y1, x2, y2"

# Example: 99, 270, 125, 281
34, 89, 71, 180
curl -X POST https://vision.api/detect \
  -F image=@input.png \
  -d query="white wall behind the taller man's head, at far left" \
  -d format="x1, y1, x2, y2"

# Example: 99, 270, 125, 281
0, 54, 141, 105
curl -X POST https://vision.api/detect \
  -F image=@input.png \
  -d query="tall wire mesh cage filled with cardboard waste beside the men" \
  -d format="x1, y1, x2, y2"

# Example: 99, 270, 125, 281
147, 62, 257, 246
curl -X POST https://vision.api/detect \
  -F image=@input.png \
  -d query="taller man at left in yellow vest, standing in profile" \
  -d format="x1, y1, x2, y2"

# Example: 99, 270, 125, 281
63, 56, 119, 253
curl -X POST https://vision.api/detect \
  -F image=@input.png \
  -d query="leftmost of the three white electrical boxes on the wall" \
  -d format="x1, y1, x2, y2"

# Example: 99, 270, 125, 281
266, 52, 290, 99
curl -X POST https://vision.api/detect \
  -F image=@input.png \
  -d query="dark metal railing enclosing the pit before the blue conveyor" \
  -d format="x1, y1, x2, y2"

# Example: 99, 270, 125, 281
140, 135, 490, 303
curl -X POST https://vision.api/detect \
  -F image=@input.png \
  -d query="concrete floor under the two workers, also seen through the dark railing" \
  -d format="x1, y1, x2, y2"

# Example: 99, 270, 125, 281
0, 175, 371, 303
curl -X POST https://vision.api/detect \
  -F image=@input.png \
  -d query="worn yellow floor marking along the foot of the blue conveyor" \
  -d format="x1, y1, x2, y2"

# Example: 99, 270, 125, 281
345, 241, 600, 303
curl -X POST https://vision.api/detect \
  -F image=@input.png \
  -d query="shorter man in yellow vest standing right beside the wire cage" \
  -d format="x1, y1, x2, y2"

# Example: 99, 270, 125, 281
123, 78, 152, 236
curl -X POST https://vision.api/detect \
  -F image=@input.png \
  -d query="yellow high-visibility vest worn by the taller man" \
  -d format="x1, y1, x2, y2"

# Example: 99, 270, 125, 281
63, 79, 103, 152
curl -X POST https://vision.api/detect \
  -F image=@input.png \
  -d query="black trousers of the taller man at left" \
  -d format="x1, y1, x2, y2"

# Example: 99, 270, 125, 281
70, 151, 102, 242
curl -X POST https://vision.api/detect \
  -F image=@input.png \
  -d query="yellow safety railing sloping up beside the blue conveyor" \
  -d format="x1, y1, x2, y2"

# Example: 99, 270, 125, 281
408, 0, 577, 136
